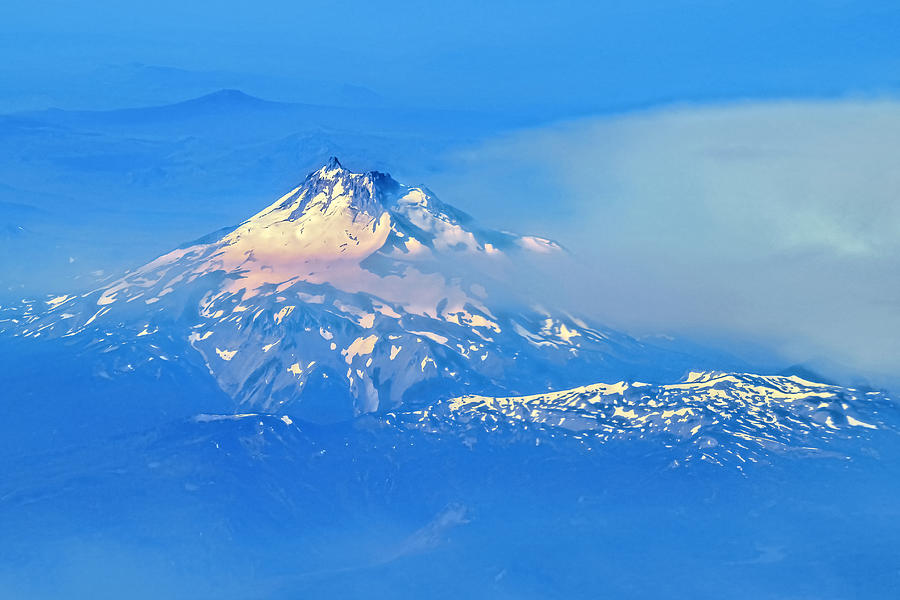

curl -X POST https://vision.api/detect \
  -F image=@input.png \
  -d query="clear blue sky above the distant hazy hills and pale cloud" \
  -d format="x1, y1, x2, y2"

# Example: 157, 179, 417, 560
0, 0, 900, 113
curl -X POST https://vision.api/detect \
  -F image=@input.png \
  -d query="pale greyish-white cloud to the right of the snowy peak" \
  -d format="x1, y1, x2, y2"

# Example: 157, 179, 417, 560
435, 100, 900, 382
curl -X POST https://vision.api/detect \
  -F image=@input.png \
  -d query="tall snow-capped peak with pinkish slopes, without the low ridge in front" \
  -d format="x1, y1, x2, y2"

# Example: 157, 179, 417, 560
0, 159, 716, 420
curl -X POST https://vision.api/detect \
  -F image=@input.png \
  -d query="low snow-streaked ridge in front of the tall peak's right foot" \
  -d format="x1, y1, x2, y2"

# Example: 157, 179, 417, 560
388, 371, 900, 466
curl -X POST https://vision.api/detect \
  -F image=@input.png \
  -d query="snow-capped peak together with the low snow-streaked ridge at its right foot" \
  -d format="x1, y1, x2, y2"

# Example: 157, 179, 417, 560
0, 159, 890, 452
